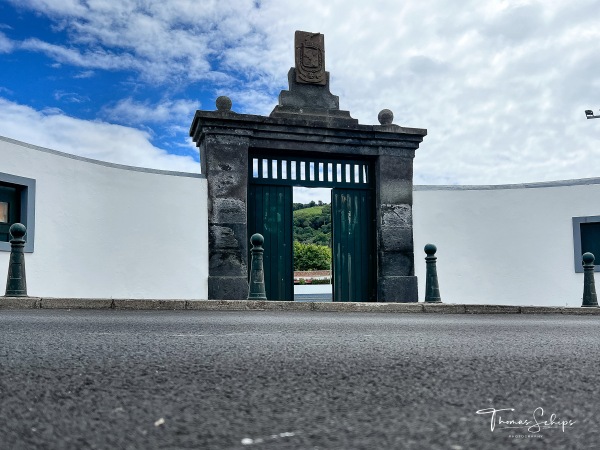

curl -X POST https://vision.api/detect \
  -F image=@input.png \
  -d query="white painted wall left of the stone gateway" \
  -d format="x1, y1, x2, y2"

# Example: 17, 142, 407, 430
0, 138, 208, 299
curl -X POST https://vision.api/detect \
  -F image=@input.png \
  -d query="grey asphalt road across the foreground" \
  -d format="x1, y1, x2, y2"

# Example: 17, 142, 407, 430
0, 310, 600, 450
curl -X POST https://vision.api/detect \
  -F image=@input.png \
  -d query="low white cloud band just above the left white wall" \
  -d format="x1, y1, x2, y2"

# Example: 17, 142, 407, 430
0, 98, 200, 172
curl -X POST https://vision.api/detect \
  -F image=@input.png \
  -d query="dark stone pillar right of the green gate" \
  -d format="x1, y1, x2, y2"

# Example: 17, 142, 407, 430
376, 150, 418, 302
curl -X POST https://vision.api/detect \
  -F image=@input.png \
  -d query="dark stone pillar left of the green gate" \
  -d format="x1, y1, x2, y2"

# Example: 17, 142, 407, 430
200, 133, 250, 300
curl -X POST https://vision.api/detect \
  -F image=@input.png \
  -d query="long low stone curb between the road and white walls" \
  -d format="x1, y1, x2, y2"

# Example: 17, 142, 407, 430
0, 297, 600, 315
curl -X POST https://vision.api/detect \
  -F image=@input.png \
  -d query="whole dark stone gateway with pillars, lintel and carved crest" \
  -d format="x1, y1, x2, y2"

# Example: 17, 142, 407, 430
190, 32, 427, 302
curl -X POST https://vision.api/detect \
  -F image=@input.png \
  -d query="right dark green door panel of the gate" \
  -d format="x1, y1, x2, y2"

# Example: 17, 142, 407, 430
331, 188, 376, 302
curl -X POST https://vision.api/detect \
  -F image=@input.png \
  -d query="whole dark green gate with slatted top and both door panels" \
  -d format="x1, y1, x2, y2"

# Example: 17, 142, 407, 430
248, 152, 376, 301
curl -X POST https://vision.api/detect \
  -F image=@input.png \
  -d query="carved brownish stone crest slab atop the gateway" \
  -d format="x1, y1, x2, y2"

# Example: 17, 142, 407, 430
295, 31, 327, 85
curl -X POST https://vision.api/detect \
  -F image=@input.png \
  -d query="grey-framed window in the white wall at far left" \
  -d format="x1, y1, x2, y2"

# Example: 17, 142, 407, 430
0, 172, 35, 253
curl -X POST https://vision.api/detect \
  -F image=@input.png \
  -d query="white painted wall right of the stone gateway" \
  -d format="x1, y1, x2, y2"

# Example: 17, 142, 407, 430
413, 179, 600, 306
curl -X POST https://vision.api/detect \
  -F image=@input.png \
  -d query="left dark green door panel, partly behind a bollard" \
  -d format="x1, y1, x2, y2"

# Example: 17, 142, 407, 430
248, 184, 294, 301
